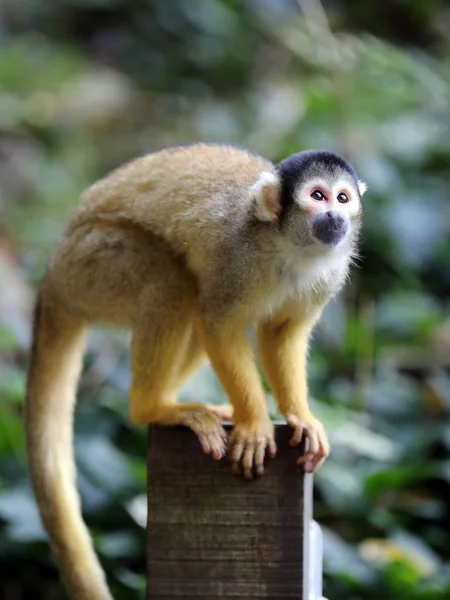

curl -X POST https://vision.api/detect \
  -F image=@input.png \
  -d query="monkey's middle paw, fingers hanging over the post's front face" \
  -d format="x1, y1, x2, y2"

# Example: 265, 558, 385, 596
229, 419, 277, 479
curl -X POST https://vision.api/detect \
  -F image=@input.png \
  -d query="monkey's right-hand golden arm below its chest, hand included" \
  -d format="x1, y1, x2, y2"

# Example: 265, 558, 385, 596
257, 310, 330, 472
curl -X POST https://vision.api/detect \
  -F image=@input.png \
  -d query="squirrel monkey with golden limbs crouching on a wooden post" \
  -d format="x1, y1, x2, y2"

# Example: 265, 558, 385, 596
27, 144, 365, 600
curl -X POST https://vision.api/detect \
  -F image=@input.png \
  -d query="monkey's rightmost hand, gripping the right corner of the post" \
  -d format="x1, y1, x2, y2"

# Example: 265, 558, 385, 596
286, 415, 330, 473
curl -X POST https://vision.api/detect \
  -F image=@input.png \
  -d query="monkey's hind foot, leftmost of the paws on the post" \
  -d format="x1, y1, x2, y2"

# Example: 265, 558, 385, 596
178, 405, 227, 460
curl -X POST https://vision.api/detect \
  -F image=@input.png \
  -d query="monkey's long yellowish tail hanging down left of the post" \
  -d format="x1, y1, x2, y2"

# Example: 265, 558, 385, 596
26, 293, 112, 600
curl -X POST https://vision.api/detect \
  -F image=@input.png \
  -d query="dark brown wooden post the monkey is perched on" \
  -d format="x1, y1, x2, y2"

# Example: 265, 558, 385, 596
147, 425, 312, 600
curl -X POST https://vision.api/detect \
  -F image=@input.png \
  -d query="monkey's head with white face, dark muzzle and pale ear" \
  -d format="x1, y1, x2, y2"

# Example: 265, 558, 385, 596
252, 150, 366, 251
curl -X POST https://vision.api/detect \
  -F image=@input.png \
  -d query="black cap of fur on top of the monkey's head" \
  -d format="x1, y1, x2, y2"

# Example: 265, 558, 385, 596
275, 150, 359, 217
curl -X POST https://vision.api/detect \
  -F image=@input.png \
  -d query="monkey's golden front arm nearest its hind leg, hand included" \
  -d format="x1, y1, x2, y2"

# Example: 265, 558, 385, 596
196, 317, 276, 479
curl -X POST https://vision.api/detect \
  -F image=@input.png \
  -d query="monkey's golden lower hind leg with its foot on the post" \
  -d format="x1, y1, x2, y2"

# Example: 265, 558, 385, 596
130, 298, 231, 460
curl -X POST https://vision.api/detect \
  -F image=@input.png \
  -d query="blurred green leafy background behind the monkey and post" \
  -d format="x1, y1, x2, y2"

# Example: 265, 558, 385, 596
0, 0, 450, 600
